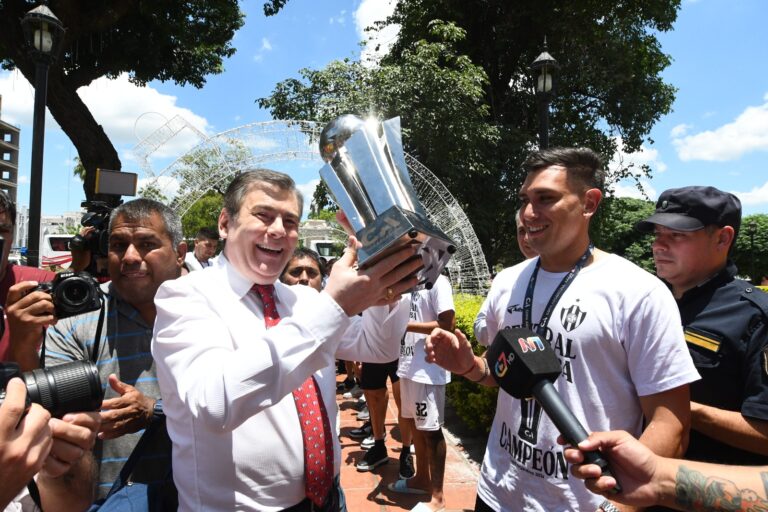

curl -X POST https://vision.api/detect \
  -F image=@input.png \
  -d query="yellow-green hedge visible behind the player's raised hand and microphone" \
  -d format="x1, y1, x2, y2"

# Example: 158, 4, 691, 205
446, 294, 499, 434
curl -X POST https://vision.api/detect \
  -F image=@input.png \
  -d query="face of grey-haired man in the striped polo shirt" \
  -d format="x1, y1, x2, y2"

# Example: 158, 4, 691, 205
108, 212, 184, 309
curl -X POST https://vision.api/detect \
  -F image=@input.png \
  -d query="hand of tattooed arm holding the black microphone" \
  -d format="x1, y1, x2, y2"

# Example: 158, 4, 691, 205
559, 431, 661, 507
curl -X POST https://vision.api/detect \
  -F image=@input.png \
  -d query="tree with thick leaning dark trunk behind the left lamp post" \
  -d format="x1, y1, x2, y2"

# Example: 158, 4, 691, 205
0, 0, 243, 206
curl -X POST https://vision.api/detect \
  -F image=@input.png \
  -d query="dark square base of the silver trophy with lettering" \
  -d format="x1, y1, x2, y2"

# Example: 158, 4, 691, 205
357, 206, 456, 291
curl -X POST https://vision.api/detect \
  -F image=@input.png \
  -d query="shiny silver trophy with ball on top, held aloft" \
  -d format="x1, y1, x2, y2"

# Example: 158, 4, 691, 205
320, 115, 456, 289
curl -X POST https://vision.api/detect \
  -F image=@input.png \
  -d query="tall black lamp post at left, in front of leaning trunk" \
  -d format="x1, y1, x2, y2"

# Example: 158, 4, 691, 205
21, 5, 64, 267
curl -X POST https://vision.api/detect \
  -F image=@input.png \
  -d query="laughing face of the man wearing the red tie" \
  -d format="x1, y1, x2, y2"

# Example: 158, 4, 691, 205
219, 183, 299, 284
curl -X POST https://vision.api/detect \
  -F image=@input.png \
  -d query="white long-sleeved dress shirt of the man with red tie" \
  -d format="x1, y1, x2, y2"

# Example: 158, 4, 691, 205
152, 256, 408, 512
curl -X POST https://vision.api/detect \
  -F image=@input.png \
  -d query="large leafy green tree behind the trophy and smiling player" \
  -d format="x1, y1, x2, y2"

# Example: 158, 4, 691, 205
259, 0, 680, 263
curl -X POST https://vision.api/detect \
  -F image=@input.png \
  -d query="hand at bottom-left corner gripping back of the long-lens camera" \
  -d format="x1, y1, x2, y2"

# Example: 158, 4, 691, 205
0, 378, 53, 508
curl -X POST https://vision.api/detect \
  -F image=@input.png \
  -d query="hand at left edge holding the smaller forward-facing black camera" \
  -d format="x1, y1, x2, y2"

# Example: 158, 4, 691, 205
6, 281, 56, 371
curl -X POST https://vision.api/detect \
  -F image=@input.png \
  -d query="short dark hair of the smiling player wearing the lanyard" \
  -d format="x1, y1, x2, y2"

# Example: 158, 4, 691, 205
523, 147, 605, 190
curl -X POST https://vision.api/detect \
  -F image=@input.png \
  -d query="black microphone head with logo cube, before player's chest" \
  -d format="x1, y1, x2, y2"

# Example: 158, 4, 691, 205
486, 328, 561, 399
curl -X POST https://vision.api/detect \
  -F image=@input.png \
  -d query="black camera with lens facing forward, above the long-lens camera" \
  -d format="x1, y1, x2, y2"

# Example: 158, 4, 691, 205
33, 271, 101, 318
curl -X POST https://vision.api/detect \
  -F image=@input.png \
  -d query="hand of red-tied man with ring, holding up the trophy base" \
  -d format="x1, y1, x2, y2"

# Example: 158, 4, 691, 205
323, 237, 423, 316
